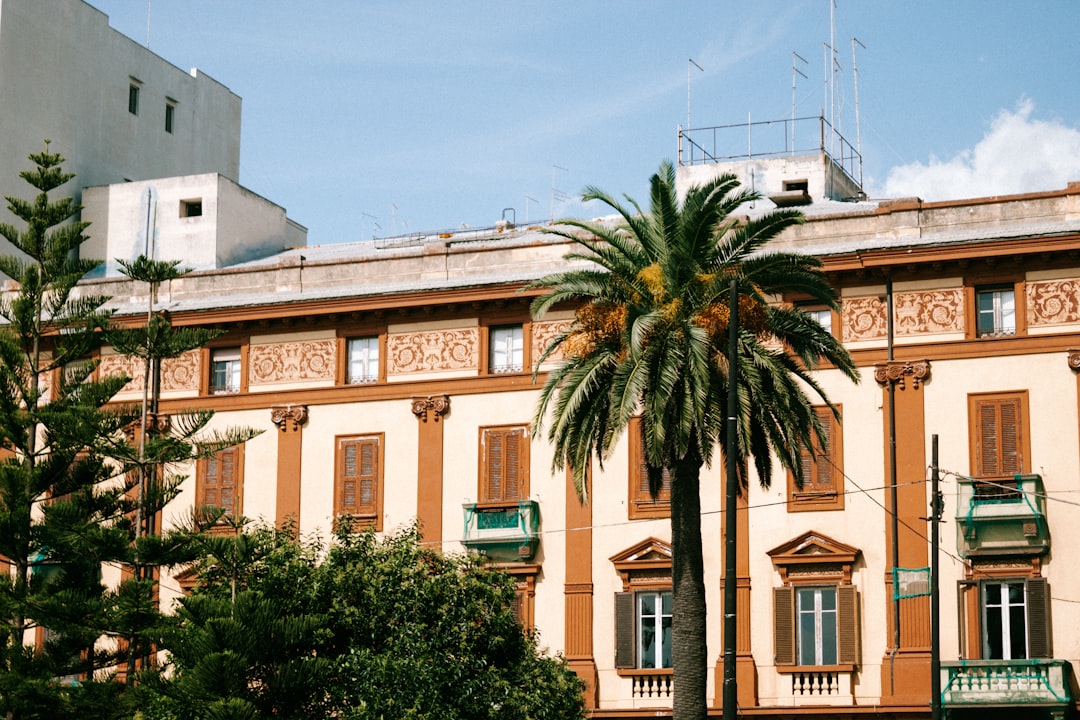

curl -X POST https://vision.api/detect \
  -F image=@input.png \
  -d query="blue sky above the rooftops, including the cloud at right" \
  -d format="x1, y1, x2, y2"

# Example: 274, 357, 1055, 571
90, 0, 1080, 244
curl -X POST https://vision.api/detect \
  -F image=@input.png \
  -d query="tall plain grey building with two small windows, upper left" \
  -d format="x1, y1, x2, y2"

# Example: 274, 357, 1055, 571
0, 0, 241, 257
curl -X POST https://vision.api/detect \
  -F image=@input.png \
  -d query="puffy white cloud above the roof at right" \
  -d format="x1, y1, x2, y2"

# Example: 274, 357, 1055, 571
874, 99, 1080, 201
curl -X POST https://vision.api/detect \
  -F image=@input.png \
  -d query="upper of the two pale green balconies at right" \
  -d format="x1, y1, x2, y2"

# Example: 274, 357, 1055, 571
956, 475, 1050, 558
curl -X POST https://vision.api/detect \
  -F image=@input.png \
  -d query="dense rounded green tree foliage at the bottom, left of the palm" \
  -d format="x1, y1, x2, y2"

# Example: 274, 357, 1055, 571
147, 527, 583, 720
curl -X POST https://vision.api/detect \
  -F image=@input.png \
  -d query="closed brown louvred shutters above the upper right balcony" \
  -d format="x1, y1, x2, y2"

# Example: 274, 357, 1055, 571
973, 395, 1026, 477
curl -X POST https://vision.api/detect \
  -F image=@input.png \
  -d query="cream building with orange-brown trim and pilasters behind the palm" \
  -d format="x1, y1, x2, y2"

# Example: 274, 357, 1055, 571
65, 144, 1080, 718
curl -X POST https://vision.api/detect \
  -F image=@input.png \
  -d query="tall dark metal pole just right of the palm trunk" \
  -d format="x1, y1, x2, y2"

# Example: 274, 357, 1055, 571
724, 280, 739, 720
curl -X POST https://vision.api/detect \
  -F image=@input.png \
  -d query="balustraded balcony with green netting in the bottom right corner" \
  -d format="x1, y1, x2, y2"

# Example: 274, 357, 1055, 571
941, 660, 1071, 710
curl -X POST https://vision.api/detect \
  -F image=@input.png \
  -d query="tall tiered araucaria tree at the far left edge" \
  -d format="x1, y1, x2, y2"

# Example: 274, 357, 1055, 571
0, 147, 134, 718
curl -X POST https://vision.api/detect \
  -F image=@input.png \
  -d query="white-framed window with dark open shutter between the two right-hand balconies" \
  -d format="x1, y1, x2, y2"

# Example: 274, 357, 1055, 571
982, 578, 1050, 660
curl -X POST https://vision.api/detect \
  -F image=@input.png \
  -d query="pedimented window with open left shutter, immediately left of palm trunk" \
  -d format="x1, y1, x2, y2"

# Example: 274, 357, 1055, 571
615, 590, 672, 669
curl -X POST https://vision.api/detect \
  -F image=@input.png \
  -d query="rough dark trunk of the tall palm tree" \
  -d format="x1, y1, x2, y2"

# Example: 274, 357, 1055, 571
671, 447, 706, 720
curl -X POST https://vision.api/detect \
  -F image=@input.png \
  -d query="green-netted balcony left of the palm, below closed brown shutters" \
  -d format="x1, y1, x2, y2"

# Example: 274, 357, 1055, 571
461, 500, 540, 561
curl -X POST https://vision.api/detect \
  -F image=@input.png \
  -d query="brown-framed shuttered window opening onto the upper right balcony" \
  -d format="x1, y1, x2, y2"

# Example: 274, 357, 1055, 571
968, 392, 1030, 497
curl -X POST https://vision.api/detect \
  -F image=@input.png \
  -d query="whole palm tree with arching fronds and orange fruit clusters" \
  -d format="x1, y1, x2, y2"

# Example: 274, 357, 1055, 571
532, 163, 858, 720
